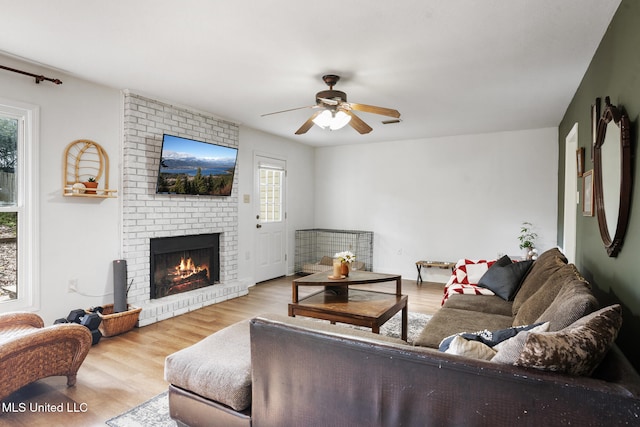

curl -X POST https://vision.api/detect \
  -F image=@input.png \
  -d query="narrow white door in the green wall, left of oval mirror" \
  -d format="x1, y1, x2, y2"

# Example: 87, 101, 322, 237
562, 123, 580, 263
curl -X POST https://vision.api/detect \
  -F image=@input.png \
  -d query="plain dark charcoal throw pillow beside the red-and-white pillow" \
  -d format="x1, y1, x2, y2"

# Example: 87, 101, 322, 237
478, 255, 533, 301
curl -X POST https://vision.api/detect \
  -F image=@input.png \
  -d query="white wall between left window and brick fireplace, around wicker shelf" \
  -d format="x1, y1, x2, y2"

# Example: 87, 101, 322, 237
0, 56, 121, 324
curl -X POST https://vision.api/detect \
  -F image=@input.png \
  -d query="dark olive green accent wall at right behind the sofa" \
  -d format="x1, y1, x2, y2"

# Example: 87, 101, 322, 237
558, 0, 640, 371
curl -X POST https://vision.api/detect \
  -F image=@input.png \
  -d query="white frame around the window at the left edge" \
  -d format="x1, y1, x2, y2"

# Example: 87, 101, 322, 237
0, 98, 40, 312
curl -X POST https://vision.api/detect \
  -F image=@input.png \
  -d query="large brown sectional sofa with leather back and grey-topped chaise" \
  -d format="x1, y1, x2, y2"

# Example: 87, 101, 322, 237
165, 249, 640, 426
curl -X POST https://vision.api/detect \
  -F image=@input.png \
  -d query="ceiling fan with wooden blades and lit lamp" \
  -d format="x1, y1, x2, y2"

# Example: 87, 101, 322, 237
261, 74, 400, 135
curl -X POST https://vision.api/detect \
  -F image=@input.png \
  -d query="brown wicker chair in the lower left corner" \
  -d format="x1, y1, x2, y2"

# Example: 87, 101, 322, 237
0, 312, 91, 400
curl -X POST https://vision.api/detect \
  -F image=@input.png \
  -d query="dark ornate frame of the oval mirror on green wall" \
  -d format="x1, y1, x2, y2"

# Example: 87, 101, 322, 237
593, 96, 631, 257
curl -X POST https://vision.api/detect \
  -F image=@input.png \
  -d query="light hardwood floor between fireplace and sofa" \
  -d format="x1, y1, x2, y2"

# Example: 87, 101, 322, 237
0, 276, 443, 427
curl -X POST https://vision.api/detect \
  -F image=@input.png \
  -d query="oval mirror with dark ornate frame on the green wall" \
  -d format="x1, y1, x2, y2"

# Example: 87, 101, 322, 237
593, 97, 631, 257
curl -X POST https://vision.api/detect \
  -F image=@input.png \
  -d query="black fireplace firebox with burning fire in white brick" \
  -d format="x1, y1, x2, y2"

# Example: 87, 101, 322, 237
150, 233, 220, 299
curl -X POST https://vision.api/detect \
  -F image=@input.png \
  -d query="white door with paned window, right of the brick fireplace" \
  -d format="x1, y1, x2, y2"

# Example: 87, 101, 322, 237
253, 154, 287, 282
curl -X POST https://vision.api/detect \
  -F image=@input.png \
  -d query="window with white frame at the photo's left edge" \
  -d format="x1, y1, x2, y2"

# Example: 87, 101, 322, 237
0, 99, 38, 311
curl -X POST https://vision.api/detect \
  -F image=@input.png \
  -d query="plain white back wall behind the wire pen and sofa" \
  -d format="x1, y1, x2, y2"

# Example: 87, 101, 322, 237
315, 128, 558, 281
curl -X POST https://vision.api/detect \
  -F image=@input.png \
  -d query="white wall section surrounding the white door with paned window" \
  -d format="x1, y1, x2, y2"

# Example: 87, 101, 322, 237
238, 126, 315, 284
